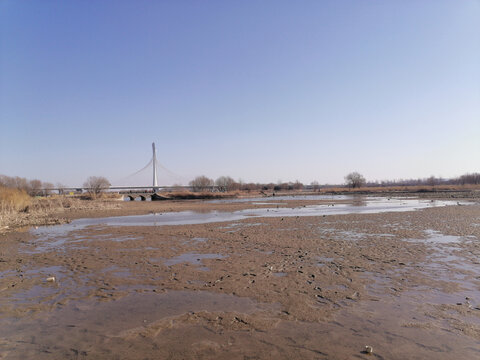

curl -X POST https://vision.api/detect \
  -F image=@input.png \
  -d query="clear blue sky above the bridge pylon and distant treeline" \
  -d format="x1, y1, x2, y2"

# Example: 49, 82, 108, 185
0, 0, 480, 186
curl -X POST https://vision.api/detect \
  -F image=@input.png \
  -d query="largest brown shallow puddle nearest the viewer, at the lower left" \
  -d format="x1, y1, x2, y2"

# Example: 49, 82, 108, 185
0, 291, 275, 348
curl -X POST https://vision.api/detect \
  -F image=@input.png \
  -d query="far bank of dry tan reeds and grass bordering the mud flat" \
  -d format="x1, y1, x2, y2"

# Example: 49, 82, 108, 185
0, 187, 480, 234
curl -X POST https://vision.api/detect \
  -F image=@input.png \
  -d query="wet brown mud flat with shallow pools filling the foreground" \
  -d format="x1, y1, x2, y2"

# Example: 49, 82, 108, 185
0, 196, 480, 359
